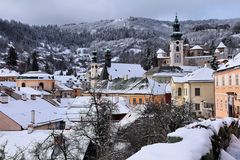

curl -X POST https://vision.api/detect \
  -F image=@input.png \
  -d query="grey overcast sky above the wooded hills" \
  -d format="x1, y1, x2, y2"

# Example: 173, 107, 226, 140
0, 0, 240, 25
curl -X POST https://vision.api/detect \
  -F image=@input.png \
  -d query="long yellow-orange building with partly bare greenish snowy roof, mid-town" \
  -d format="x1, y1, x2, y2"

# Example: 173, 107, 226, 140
83, 77, 171, 106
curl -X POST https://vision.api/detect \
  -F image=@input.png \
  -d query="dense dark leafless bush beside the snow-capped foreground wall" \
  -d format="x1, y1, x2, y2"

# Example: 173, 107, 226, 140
115, 103, 194, 159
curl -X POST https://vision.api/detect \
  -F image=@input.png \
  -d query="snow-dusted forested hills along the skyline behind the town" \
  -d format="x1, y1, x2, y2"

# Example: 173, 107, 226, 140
0, 17, 240, 58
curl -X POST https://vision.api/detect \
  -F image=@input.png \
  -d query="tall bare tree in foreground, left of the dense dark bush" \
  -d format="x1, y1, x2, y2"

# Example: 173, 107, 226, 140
75, 92, 115, 160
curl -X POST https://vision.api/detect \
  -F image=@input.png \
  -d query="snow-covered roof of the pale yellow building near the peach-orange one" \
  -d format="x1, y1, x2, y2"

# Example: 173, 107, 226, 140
172, 67, 214, 83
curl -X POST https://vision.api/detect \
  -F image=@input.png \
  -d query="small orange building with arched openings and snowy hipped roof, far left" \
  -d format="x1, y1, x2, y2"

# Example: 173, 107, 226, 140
16, 71, 55, 91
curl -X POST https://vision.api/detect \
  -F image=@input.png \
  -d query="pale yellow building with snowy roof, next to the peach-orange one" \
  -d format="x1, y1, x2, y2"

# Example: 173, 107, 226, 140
171, 67, 214, 118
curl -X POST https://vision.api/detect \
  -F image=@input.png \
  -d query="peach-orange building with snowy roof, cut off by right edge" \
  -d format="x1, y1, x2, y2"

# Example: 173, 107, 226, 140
214, 54, 240, 118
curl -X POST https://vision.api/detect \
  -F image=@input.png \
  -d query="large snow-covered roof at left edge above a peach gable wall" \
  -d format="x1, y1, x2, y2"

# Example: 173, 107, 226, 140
0, 97, 65, 128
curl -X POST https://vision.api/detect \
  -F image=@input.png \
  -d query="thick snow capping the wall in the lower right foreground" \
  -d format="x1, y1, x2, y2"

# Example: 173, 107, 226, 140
128, 118, 240, 160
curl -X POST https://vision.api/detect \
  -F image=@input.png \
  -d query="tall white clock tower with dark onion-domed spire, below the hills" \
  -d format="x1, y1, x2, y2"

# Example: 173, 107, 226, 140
170, 16, 184, 66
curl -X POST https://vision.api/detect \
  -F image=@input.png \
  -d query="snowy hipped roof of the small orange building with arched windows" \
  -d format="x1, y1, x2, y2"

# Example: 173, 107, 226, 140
18, 71, 54, 80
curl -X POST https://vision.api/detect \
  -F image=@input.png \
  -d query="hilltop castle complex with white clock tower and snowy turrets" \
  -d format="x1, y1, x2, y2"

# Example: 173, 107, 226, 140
157, 16, 228, 66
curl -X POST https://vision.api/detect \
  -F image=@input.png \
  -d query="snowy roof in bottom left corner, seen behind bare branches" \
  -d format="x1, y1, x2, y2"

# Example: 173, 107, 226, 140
0, 130, 89, 159
